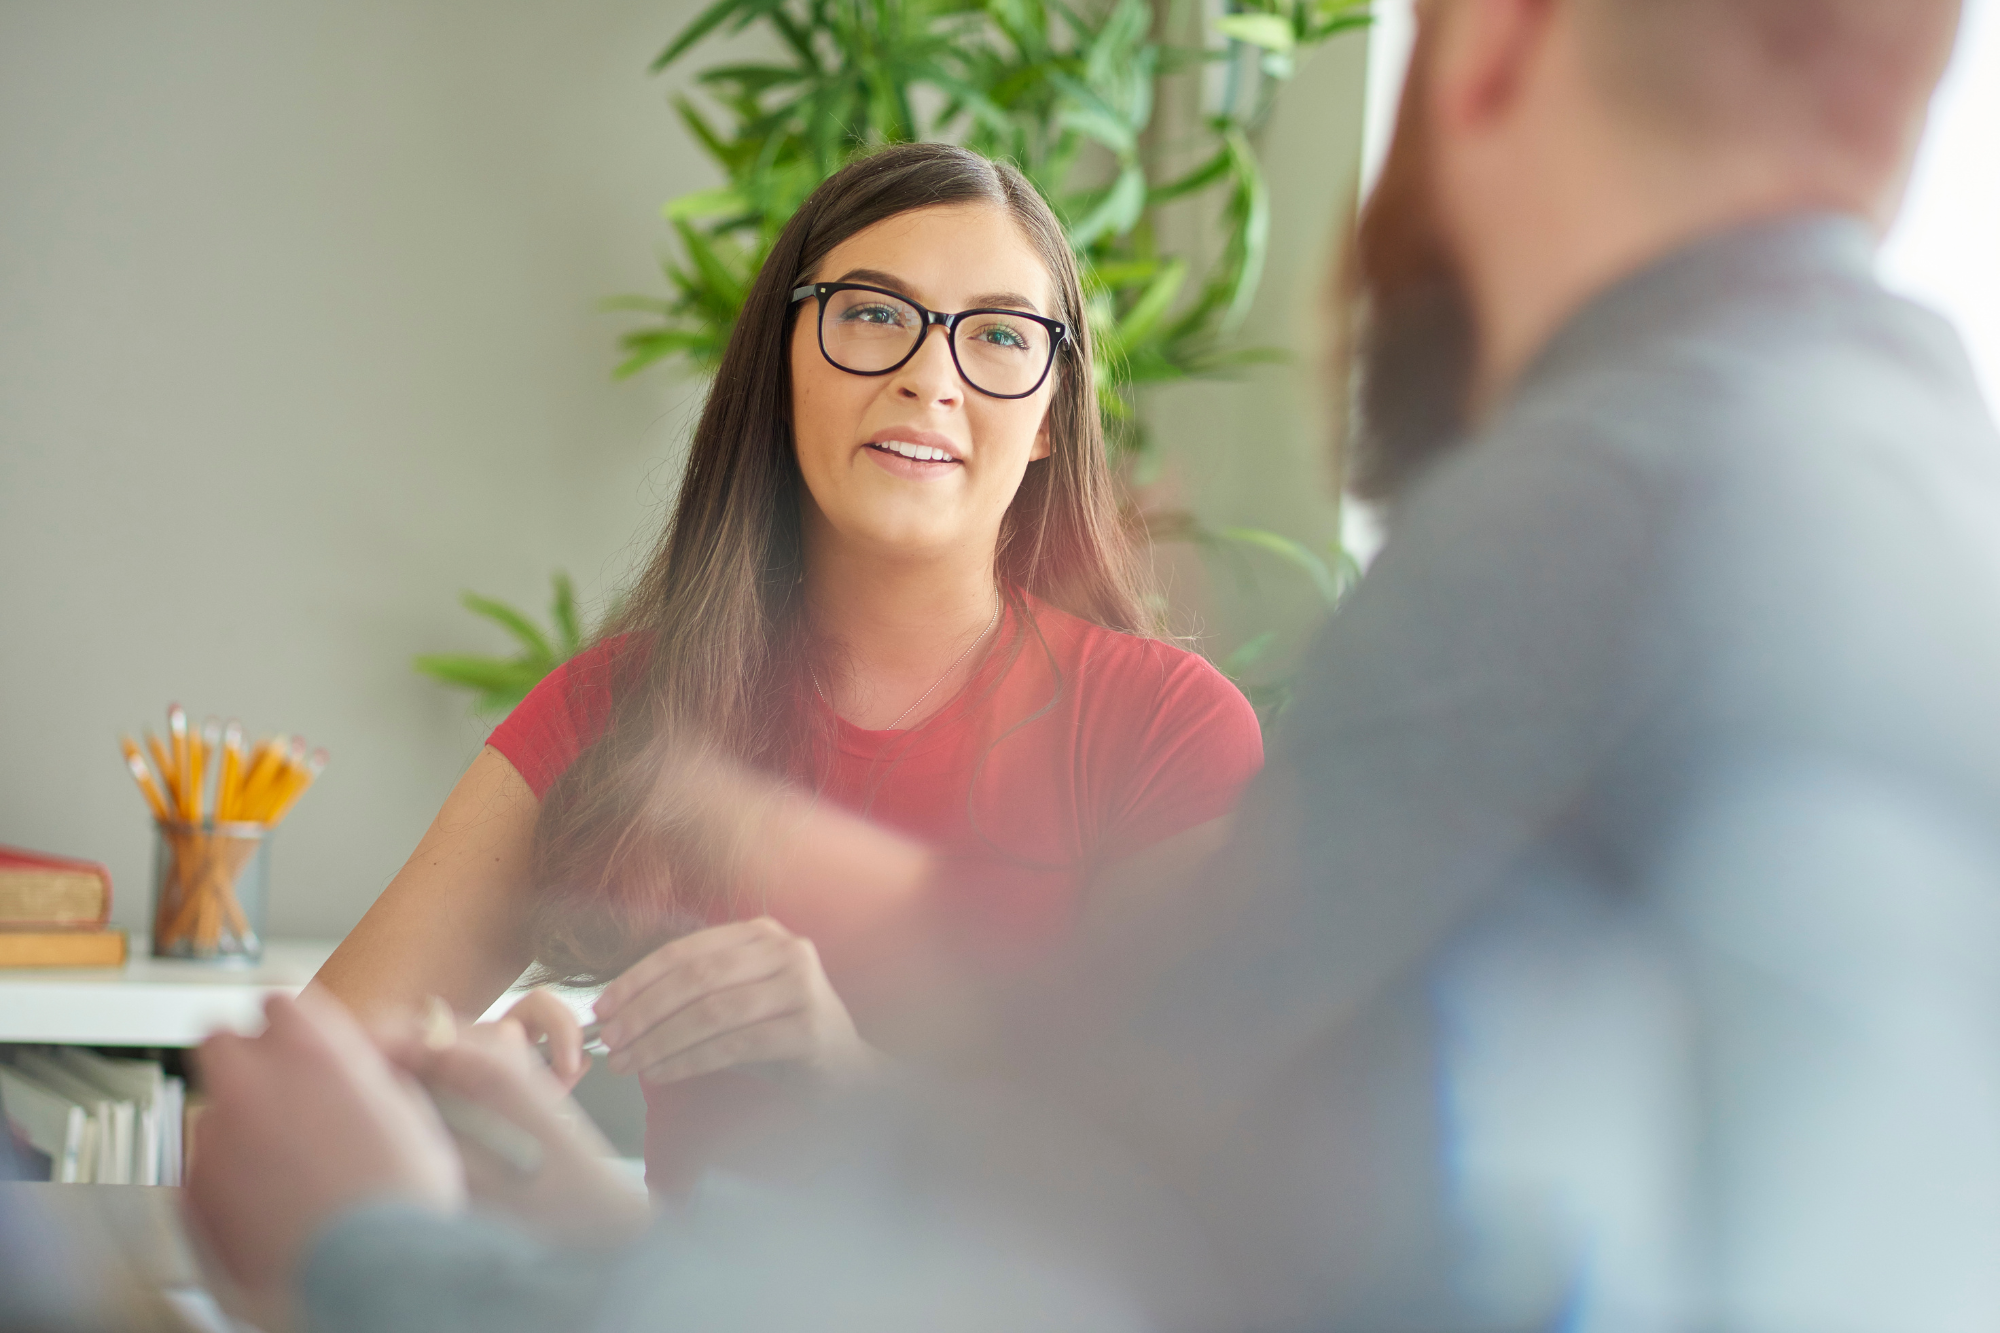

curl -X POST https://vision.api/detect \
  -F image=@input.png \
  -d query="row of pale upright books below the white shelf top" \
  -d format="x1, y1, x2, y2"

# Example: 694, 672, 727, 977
0, 1047, 188, 1185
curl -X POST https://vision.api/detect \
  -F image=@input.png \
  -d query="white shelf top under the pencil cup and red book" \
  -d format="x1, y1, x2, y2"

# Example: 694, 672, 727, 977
0, 935, 334, 1047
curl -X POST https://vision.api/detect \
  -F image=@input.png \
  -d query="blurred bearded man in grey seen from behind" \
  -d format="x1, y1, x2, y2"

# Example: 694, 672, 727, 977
1072, 0, 2000, 1331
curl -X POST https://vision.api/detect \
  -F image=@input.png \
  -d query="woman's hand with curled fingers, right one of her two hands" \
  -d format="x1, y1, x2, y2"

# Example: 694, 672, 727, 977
598, 917, 880, 1083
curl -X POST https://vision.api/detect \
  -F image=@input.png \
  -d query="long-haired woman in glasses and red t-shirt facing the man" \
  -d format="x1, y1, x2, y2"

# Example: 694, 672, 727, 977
320, 144, 1262, 1193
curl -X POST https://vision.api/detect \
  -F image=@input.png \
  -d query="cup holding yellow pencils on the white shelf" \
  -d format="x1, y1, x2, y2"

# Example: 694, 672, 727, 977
152, 823, 270, 963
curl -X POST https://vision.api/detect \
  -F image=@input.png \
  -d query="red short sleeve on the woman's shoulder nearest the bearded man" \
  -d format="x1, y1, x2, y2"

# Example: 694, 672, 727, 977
1096, 642, 1264, 863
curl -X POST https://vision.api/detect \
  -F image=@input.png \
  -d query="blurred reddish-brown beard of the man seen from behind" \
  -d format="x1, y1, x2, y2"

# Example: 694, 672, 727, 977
1346, 34, 1474, 500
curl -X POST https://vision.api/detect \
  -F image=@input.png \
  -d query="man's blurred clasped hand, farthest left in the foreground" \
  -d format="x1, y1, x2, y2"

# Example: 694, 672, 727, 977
186, 991, 466, 1299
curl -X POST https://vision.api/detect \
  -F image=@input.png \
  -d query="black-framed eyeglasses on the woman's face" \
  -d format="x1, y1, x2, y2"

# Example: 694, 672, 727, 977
792, 282, 1070, 398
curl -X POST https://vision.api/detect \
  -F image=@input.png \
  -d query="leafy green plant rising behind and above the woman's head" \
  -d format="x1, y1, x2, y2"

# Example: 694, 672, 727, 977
610, 0, 1368, 462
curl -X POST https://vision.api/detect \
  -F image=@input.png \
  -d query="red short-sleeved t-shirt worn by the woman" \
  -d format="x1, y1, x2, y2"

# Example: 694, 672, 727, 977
488, 598, 1264, 1187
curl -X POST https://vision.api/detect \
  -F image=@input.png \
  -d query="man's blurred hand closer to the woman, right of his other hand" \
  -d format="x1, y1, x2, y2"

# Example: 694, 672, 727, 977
384, 997, 652, 1247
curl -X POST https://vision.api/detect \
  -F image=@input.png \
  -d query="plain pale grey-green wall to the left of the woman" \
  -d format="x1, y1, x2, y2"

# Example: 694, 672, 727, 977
0, 0, 712, 935
